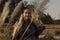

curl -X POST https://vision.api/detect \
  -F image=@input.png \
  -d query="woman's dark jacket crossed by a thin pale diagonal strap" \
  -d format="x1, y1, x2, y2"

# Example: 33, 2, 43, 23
14, 20, 45, 40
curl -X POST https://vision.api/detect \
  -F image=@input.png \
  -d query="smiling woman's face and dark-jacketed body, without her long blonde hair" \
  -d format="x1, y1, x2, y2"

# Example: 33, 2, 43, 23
13, 7, 45, 40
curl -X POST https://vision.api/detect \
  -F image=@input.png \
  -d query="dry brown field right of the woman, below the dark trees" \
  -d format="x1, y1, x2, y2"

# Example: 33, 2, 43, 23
40, 24, 60, 40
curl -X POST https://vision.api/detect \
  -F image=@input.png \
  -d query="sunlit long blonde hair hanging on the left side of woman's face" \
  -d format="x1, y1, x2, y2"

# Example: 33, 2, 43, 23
12, 15, 23, 40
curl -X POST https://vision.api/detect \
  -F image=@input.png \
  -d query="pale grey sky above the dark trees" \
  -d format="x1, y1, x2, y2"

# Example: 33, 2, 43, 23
23, 0, 60, 19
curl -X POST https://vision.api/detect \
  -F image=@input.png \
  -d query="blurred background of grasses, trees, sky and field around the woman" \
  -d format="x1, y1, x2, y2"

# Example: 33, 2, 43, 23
0, 0, 60, 40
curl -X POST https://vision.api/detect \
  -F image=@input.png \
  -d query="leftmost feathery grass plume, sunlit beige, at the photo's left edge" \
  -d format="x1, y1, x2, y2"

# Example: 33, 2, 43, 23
0, 0, 11, 26
